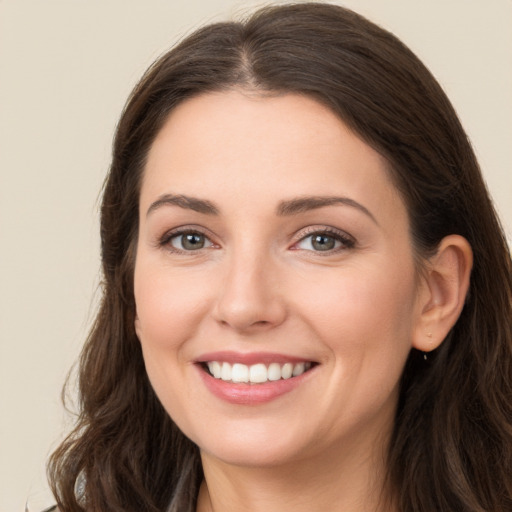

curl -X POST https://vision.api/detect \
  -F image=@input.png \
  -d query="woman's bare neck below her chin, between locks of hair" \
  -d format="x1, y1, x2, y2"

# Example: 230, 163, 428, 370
197, 432, 394, 512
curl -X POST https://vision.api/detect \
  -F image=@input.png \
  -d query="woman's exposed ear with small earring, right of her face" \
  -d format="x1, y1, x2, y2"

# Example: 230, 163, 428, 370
412, 235, 473, 352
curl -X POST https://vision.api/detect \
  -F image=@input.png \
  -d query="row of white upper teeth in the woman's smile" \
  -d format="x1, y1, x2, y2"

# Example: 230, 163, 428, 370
207, 361, 312, 384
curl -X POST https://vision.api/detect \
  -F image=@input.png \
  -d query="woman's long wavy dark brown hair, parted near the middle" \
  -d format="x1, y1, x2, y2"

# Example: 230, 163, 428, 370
49, 3, 512, 512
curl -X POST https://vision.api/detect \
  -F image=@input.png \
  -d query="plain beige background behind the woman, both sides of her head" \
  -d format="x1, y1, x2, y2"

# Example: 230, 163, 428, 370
0, 0, 512, 512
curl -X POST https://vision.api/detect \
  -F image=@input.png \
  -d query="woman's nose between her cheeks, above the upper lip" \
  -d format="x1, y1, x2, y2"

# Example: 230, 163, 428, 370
214, 250, 286, 333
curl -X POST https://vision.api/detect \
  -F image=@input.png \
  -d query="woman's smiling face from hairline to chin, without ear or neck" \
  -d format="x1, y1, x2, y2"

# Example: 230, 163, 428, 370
135, 91, 421, 466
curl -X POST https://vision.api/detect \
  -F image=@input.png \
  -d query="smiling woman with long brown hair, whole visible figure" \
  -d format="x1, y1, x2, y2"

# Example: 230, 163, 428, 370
50, 3, 512, 512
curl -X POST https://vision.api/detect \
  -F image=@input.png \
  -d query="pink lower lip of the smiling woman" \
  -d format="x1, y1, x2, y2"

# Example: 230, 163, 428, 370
198, 366, 313, 405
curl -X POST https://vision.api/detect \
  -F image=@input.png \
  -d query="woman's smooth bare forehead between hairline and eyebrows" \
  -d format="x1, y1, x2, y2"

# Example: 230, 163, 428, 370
141, 91, 403, 224
